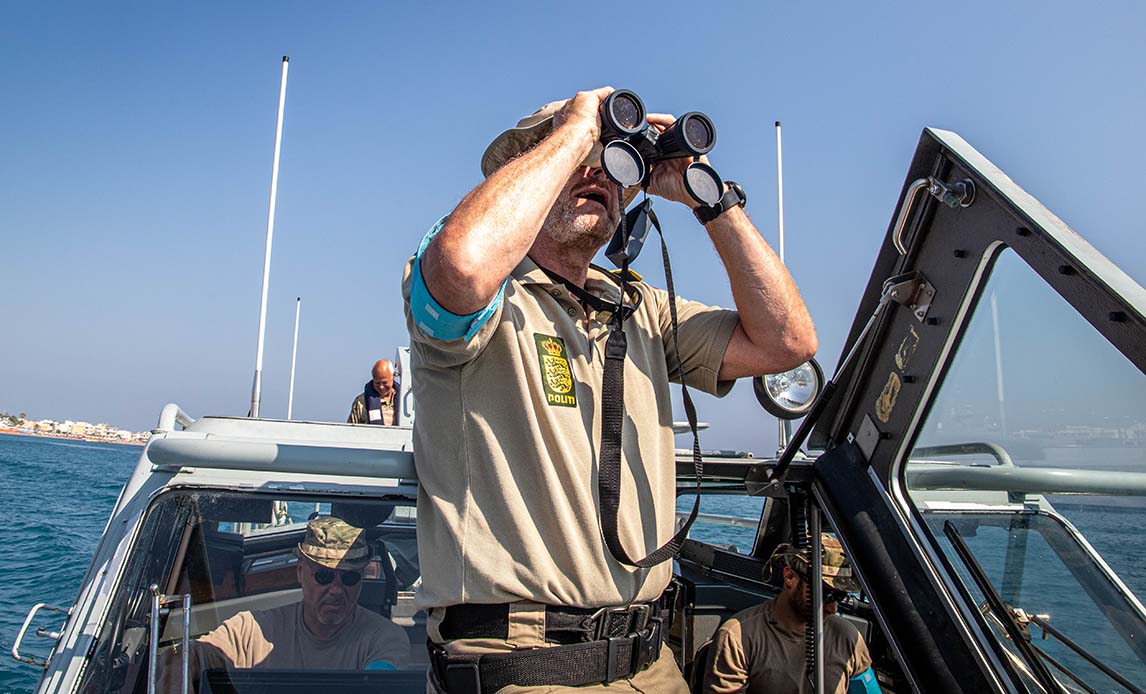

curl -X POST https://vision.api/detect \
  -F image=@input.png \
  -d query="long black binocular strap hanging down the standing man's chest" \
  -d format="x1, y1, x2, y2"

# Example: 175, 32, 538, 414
597, 195, 704, 569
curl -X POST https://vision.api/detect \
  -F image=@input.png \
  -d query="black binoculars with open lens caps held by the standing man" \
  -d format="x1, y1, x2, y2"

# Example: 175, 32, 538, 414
601, 89, 724, 205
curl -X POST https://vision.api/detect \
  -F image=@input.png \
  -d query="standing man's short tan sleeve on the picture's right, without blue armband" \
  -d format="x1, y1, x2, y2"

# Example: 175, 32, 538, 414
649, 287, 740, 397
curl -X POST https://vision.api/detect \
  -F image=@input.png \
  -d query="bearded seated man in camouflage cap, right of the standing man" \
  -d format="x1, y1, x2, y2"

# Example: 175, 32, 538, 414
698, 535, 880, 694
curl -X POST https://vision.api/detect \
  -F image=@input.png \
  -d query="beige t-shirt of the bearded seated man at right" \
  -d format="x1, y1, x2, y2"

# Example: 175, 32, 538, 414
704, 600, 871, 694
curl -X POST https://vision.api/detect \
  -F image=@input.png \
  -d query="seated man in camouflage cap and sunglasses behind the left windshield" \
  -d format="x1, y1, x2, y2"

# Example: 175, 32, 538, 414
174, 516, 410, 677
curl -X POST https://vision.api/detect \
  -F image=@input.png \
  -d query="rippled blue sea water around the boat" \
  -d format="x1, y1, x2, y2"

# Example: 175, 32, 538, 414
0, 435, 1146, 694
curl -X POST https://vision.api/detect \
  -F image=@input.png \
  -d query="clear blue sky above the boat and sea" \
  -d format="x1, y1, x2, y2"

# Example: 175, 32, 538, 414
0, 1, 1146, 452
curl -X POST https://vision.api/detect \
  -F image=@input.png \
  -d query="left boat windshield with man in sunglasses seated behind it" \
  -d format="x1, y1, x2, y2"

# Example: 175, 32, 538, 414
81, 490, 426, 692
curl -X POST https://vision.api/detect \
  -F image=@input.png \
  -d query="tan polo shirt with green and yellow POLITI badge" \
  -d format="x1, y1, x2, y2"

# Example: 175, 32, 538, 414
402, 258, 739, 607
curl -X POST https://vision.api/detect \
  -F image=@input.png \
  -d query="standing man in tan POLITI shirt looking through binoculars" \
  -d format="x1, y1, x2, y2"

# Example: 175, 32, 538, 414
402, 87, 816, 693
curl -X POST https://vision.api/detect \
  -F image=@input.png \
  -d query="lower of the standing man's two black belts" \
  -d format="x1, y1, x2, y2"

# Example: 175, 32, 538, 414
426, 617, 664, 694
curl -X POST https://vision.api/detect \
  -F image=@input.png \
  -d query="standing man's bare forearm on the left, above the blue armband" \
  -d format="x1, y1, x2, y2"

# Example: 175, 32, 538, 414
421, 121, 594, 315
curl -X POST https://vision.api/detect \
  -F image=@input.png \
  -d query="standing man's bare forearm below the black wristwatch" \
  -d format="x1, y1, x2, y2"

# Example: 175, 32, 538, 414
705, 207, 817, 379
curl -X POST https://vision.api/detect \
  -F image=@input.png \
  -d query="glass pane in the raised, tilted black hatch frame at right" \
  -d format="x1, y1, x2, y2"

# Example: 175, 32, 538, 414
903, 250, 1146, 692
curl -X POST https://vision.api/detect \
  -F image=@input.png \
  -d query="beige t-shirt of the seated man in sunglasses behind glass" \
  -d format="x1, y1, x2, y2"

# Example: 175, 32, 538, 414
191, 602, 410, 672
